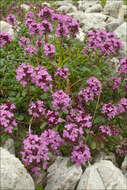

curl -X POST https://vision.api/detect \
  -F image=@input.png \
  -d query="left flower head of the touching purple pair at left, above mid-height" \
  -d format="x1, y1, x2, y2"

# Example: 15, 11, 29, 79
16, 63, 35, 86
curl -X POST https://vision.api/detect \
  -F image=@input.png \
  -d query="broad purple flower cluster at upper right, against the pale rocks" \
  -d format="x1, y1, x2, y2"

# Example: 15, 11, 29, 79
84, 30, 122, 55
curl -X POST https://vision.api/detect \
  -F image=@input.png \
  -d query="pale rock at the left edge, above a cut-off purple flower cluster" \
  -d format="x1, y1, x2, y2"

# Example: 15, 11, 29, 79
0, 21, 15, 39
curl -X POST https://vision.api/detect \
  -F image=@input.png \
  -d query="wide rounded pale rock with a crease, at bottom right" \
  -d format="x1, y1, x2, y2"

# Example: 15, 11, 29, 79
76, 160, 127, 190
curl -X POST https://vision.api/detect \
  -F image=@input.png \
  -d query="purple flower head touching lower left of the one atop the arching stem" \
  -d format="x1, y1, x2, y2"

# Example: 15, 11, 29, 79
78, 87, 94, 102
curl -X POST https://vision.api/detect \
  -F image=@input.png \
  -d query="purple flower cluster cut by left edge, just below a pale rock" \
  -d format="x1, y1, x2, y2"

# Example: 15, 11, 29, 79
0, 32, 12, 47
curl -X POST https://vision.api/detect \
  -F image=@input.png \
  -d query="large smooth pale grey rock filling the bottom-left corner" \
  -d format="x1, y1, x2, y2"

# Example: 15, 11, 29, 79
0, 148, 35, 190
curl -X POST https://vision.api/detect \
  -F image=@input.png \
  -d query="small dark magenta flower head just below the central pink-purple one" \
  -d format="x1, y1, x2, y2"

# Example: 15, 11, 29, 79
46, 110, 62, 126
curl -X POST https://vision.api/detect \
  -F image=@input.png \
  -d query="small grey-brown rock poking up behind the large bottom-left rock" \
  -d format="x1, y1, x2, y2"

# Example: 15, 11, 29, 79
3, 138, 15, 155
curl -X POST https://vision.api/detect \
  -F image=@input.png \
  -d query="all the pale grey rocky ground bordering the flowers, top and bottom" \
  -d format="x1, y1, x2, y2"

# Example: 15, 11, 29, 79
0, 0, 127, 190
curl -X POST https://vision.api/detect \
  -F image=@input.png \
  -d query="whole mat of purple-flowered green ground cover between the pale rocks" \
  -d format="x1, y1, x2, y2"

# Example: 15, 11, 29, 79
0, 0, 127, 187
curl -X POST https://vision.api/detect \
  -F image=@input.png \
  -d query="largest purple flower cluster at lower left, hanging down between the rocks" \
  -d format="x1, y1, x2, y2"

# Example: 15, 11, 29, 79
21, 129, 64, 177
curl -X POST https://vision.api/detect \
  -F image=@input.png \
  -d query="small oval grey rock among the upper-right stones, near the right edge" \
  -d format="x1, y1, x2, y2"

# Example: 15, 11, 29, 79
106, 19, 122, 32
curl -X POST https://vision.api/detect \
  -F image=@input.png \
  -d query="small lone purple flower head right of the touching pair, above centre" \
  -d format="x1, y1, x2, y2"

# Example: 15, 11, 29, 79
55, 67, 70, 79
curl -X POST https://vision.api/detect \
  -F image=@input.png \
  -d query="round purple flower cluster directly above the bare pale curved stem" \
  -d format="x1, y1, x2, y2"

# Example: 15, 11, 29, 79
28, 100, 46, 118
